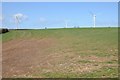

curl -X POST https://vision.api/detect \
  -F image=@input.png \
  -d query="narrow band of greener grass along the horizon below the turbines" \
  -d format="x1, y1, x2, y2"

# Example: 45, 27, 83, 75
3, 28, 118, 44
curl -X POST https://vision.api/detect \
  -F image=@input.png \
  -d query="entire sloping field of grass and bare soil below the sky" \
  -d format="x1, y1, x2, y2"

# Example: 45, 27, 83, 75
2, 28, 118, 78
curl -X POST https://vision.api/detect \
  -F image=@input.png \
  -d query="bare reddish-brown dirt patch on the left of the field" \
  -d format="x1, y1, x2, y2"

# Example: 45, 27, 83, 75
2, 39, 56, 77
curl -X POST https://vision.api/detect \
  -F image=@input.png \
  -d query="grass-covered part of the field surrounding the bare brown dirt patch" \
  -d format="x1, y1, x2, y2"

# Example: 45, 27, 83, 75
2, 28, 118, 78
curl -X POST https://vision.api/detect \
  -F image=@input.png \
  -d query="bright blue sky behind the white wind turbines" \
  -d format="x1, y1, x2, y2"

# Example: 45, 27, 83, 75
2, 2, 118, 29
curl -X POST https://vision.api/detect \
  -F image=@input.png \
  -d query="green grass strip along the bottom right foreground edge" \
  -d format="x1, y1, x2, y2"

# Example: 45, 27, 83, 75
33, 67, 118, 78
